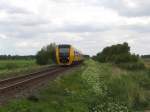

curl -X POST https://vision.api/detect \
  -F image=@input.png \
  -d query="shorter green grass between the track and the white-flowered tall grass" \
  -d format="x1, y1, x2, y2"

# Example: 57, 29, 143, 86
0, 64, 90, 112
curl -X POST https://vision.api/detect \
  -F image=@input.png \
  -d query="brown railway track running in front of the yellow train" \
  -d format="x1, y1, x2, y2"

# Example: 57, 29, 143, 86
0, 66, 72, 102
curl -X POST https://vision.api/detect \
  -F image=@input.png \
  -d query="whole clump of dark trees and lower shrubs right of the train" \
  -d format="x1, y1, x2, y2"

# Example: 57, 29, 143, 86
93, 42, 145, 69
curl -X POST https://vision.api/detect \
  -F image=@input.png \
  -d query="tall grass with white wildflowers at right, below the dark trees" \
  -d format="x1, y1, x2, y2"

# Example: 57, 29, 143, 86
82, 60, 150, 112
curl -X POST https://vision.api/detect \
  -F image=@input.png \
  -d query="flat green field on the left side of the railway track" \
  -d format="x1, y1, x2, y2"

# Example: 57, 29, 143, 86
0, 60, 47, 79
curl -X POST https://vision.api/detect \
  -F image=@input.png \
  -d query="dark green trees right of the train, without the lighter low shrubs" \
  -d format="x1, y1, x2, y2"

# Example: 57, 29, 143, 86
94, 42, 139, 63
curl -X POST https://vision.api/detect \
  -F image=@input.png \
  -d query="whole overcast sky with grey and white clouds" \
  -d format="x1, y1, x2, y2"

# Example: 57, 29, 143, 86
0, 0, 150, 55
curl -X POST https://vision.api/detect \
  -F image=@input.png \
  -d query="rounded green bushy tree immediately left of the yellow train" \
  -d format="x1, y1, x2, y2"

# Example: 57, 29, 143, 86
36, 43, 56, 65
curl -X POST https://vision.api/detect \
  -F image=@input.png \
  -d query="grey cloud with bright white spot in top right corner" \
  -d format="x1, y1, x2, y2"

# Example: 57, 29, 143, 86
95, 0, 150, 17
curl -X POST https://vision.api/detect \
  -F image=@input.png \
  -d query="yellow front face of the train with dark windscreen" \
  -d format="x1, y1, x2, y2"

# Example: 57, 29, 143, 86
56, 45, 73, 65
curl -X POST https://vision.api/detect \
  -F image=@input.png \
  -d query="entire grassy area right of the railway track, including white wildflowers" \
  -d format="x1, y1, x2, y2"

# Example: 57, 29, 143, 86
0, 60, 150, 112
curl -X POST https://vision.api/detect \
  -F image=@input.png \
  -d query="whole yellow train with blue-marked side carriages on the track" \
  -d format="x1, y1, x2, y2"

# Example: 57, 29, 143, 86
56, 44, 83, 66
